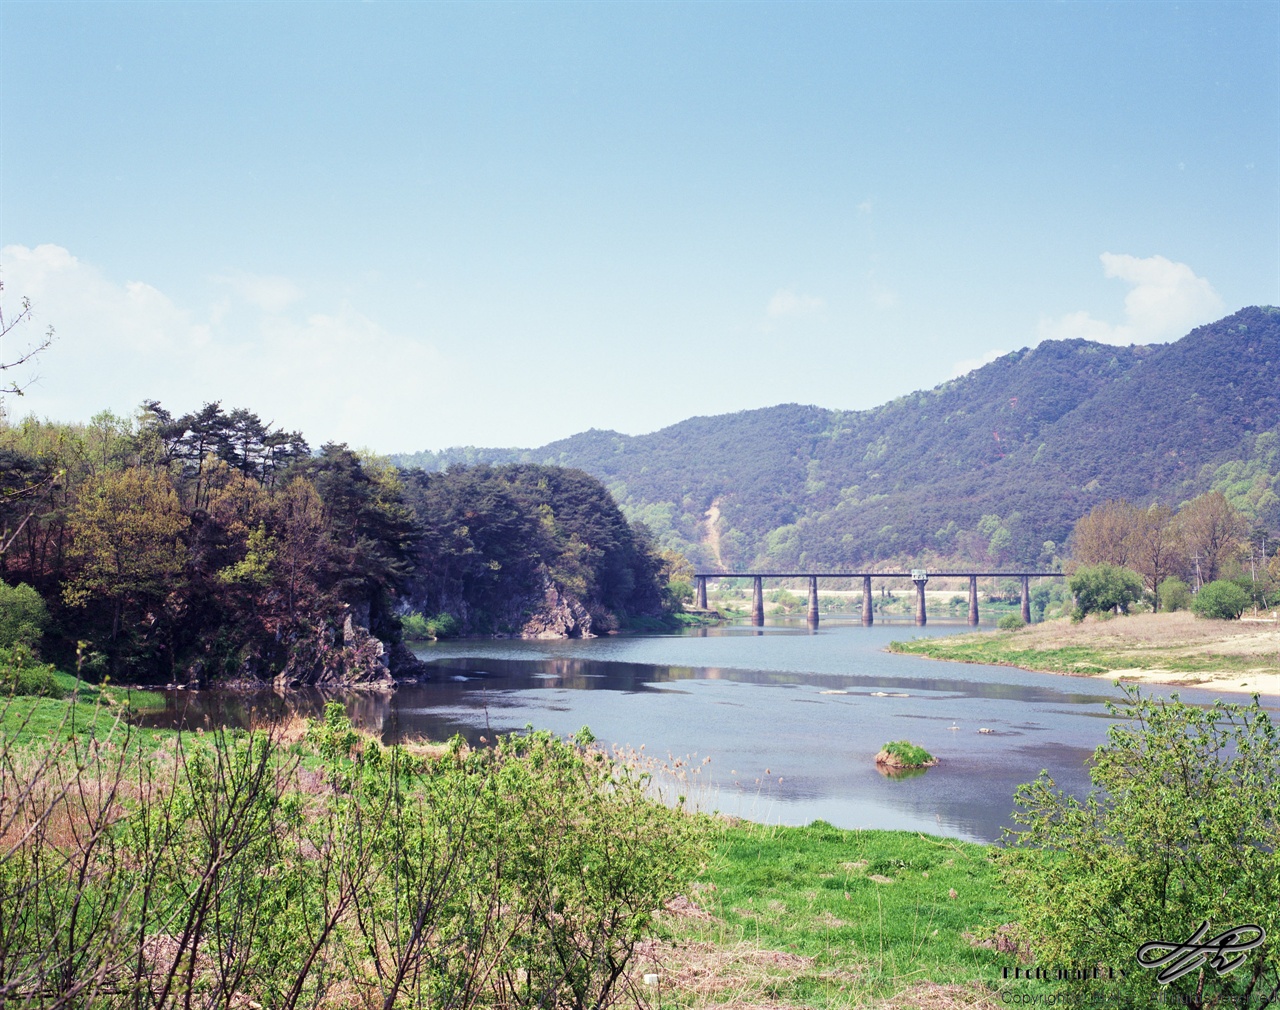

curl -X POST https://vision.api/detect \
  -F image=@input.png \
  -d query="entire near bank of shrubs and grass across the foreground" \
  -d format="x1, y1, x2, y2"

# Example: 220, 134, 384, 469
0, 675, 1280, 1010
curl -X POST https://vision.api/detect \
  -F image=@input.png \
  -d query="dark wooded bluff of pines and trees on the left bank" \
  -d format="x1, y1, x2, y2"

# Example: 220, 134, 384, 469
0, 401, 662, 682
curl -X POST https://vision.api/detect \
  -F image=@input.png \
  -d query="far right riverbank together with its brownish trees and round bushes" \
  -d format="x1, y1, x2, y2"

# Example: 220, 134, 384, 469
890, 492, 1280, 687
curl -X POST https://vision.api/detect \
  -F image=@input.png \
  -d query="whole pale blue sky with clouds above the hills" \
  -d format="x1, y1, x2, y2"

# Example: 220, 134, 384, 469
0, 0, 1280, 452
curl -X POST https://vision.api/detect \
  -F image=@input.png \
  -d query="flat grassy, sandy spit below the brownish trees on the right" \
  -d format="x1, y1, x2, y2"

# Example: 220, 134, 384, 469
888, 611, 1280, 694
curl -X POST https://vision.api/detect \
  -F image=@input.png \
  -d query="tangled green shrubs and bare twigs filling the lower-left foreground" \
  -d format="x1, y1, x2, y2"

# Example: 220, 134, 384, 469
0, 699, 707, 1010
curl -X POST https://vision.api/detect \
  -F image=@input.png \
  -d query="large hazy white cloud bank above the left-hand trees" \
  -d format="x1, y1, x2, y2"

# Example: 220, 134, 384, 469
0, 244, 467, 449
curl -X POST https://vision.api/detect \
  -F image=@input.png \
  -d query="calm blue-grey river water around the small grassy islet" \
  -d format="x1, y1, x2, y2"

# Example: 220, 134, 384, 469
142, 620, 1280, 841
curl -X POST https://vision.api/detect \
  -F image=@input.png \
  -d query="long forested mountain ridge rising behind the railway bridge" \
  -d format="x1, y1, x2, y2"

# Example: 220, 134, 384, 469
394, 307, 1280, 568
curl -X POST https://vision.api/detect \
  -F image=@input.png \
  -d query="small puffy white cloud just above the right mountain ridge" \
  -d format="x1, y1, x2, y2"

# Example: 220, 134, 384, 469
1038, 252, 1222, 346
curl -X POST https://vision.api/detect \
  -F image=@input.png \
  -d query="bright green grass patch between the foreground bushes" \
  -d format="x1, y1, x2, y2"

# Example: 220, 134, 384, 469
650, 822, 1015, 1007
